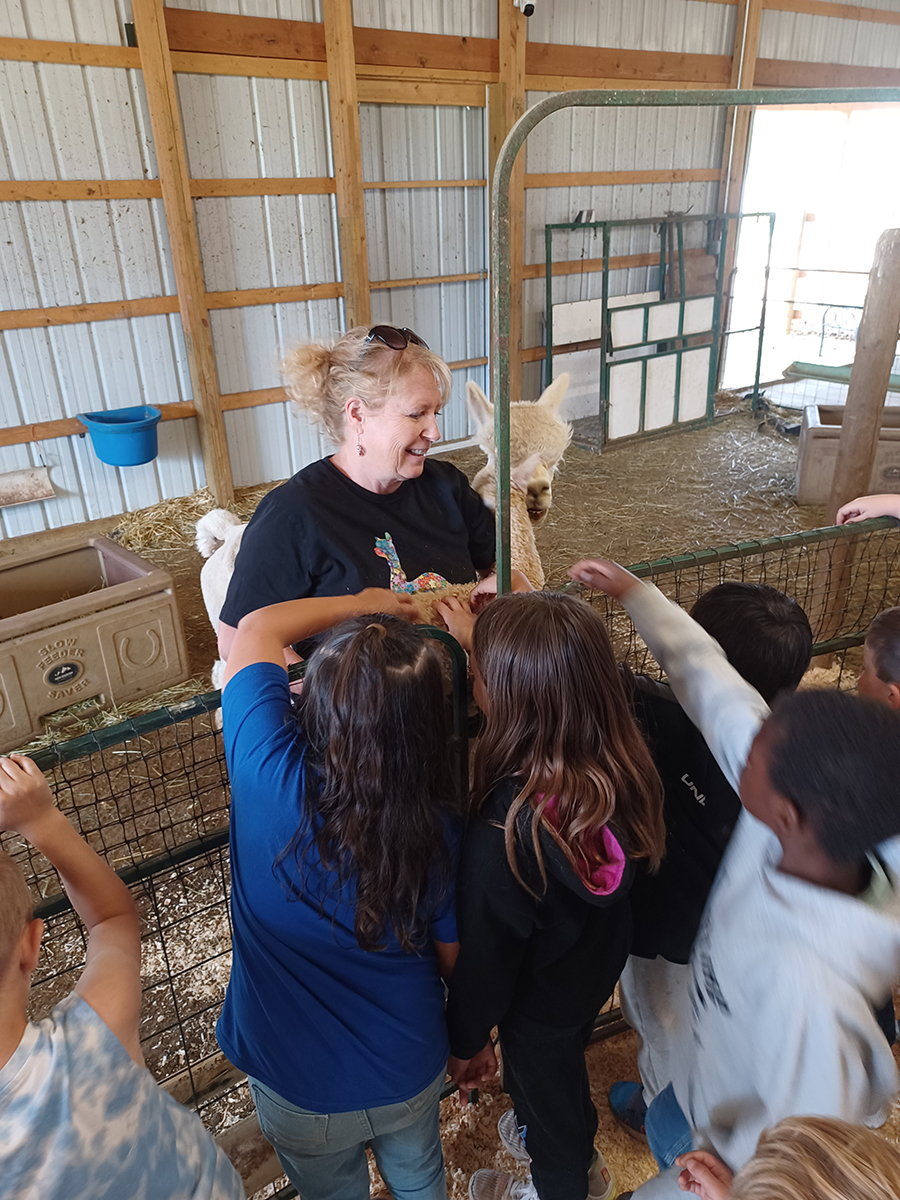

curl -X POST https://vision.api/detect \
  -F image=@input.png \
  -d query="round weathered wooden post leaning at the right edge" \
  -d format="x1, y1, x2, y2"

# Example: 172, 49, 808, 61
809, 229, 900, 657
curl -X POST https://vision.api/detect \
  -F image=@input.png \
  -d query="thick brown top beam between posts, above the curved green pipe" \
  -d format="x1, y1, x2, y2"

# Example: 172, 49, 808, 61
526, 42, 731, 88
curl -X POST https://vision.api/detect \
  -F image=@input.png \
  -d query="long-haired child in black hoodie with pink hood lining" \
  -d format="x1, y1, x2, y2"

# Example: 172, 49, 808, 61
442, 592, 665, 1200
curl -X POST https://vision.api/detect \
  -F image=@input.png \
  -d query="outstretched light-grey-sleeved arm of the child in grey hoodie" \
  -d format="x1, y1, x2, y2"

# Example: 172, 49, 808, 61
569, 559, 769, 791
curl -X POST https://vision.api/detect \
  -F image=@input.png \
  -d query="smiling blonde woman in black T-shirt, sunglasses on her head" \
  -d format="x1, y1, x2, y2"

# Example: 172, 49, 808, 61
218, 325, 494, 659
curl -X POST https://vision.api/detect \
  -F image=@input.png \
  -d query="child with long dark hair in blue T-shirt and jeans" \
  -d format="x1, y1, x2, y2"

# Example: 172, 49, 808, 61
216, 588, 458, 1200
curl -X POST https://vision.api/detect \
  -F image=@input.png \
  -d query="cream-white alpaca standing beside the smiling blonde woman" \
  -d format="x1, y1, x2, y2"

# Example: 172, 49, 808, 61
197, 374, 572, 688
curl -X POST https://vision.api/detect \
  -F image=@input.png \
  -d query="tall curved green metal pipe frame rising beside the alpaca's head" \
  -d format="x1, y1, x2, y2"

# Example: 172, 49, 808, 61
491, 88, 900, 594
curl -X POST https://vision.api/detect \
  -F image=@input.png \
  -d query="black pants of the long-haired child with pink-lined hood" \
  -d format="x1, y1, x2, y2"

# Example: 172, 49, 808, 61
499, 1015, 596, 1200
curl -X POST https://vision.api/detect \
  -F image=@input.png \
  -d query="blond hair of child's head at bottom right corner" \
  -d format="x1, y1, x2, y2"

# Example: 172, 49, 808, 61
728, 1117, 900, 1200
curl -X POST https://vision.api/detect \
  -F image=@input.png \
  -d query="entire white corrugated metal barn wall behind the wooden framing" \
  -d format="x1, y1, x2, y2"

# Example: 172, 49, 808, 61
0, 0, 900, 536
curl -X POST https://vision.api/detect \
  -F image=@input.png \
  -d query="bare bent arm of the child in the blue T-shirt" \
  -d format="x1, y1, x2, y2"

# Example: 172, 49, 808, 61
223, 588, 415, 686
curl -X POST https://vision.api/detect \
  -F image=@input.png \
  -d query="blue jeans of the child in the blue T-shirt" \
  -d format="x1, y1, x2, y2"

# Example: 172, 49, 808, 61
248, 1072, 446, 1200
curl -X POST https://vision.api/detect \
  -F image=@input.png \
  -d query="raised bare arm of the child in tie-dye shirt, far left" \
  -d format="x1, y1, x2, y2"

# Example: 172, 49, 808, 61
0, 755, 144, 1067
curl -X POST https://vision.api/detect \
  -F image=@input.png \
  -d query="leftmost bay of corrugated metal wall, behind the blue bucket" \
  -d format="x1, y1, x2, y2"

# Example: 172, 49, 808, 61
0, 0, 204, 536
